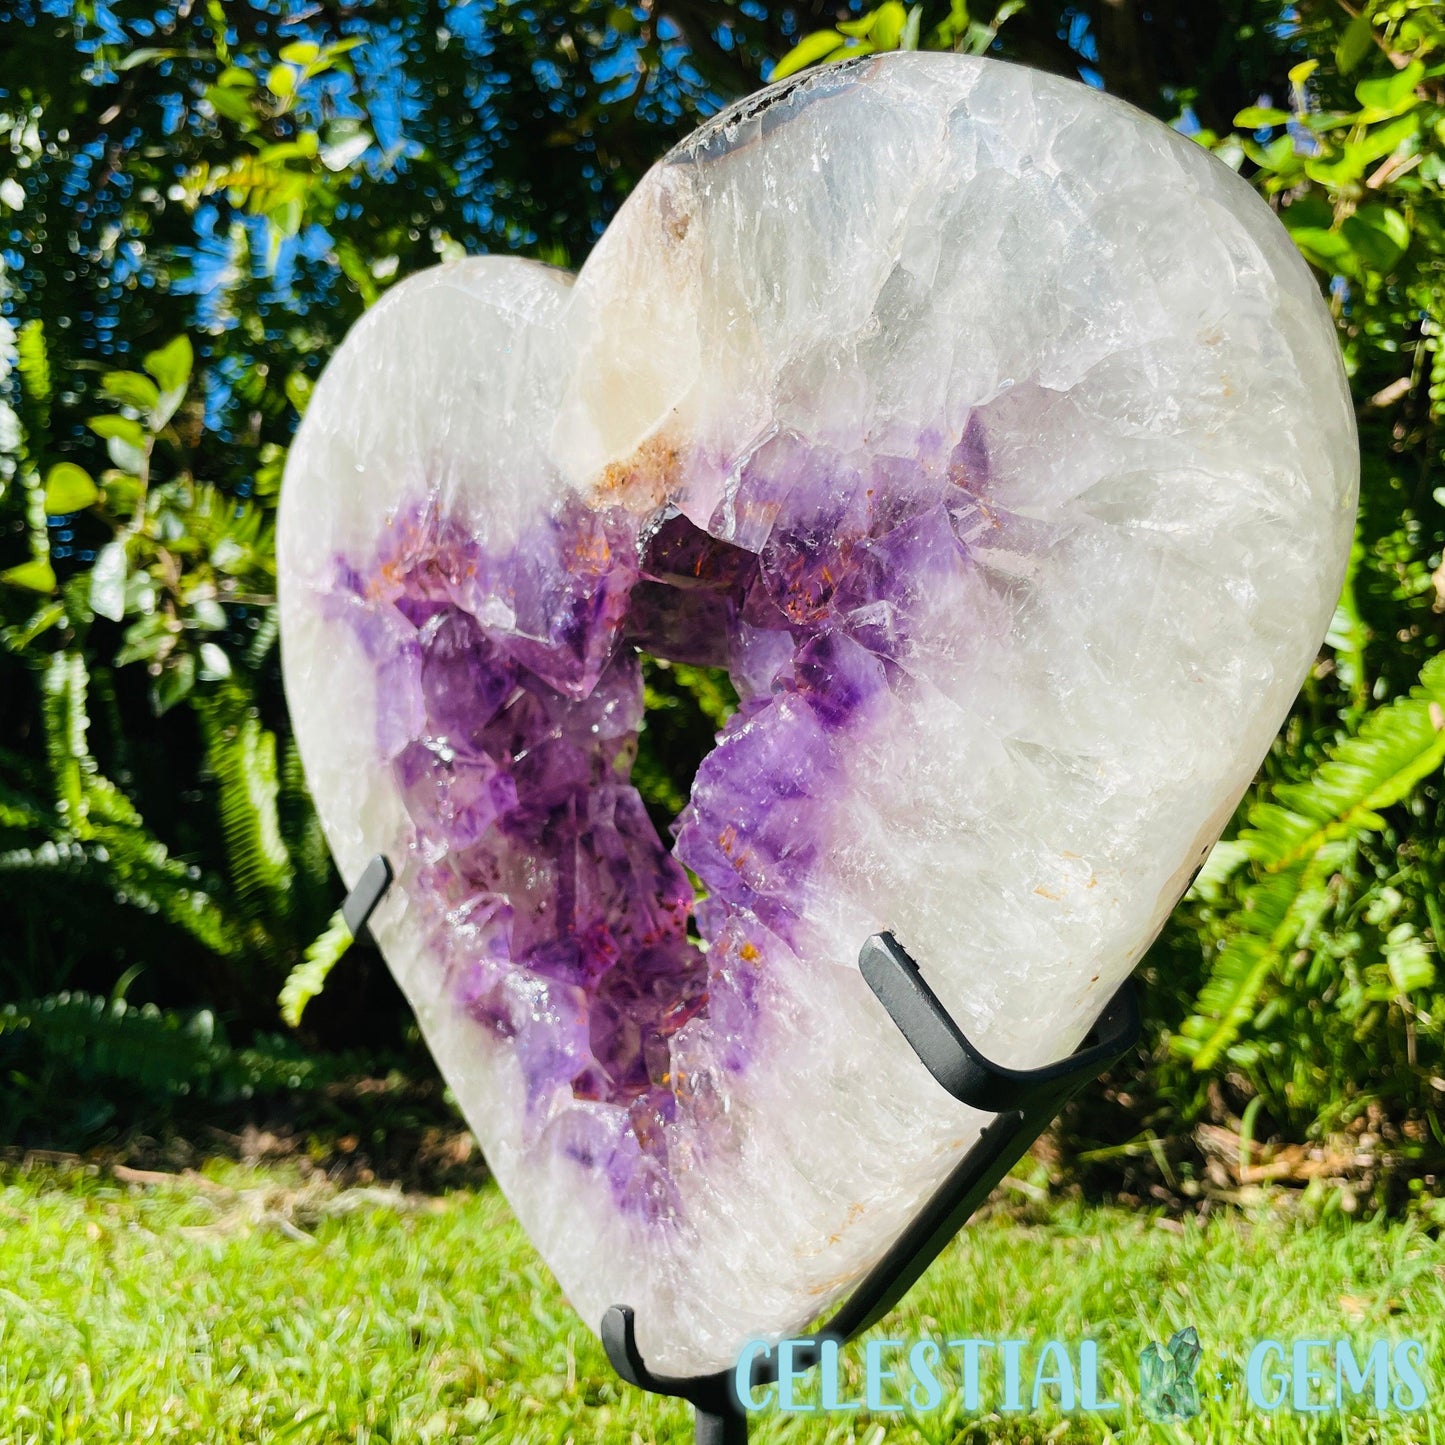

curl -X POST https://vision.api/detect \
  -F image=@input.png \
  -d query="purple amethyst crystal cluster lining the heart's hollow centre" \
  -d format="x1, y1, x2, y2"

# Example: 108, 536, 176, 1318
327, 425, 985, 1220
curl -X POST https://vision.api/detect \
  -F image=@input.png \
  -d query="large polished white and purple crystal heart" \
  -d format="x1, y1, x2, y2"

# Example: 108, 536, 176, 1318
279, 55, 1357, 1373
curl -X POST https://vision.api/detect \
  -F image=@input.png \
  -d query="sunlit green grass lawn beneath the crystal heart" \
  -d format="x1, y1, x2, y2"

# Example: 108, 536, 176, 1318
0, 1165, 1445, 1445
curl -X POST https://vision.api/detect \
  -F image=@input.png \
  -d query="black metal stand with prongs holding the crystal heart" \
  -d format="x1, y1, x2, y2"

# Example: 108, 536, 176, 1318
342, 855, 1139, 1445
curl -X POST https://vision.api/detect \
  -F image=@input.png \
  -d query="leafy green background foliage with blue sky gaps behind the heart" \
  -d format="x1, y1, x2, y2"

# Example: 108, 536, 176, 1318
0, 0, 1445, 1188
